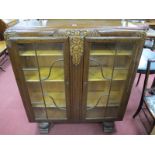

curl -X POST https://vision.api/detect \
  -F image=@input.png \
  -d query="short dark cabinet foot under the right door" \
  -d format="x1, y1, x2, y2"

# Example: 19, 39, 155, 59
103, 121, 115, 133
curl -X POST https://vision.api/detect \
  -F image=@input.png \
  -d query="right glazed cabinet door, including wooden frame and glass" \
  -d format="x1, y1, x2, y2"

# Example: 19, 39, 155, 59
82, 37, 142, 120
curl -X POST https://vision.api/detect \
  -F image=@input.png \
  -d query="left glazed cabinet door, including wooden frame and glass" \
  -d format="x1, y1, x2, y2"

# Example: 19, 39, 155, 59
10, 38, 70, 121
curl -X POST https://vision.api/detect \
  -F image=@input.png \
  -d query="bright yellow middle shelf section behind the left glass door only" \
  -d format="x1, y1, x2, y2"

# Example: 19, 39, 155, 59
23, 67, 64, 82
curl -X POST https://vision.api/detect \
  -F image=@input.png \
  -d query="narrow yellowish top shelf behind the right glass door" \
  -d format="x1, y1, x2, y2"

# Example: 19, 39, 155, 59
90, 50, 132, 56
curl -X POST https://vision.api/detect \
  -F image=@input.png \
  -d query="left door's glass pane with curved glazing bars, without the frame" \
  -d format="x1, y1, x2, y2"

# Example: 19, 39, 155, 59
19, 43, 67, 120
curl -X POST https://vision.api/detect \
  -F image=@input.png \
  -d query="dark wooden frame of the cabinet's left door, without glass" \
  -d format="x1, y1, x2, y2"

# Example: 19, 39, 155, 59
7, 37, 71, 122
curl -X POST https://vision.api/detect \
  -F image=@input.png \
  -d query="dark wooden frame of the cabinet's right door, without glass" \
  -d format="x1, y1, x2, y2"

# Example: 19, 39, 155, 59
81, 36, 144, 121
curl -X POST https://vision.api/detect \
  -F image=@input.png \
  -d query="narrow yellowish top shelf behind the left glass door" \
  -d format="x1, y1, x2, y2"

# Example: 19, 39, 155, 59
20, 50, 63, 56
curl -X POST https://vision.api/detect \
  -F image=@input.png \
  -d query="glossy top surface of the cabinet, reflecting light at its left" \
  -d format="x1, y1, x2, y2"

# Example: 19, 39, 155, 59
5, 19, 145, 31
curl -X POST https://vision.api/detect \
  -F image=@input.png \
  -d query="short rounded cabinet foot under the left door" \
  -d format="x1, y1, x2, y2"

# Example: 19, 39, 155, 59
38, 122, 51, 134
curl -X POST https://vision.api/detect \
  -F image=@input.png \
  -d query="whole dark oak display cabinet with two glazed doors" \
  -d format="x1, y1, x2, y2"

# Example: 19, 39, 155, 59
5, 20, 145, 133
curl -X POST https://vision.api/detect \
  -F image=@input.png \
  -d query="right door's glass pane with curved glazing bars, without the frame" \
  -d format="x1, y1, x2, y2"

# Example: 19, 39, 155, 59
86, 42, 133, 119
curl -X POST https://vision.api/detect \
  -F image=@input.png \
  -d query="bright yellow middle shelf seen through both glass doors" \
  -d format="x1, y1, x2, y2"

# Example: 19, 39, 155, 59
23, 67, 128, 82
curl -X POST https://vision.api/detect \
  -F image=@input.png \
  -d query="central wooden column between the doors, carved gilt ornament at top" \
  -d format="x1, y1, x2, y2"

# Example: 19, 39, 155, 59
69, 35, 84, 122
